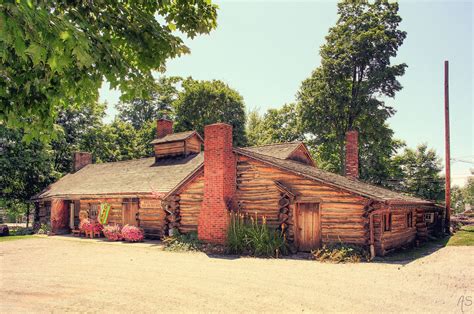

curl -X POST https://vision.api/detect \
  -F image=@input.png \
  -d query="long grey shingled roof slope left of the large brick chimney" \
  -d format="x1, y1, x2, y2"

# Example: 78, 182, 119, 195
34, 153, 204, 199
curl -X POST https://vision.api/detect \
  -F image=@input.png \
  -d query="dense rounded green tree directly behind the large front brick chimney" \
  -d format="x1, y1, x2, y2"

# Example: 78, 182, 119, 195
174, 78, 247, 146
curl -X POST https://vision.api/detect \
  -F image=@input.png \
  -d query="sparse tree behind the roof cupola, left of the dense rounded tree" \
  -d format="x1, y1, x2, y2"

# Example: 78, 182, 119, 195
116, 76, 182, 130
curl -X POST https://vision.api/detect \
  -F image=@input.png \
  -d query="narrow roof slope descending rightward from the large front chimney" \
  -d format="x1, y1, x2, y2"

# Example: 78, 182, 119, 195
235, 148, 431, 204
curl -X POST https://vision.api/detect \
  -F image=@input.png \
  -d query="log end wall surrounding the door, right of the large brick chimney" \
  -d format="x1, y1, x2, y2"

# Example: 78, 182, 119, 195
236, 156, 369, 245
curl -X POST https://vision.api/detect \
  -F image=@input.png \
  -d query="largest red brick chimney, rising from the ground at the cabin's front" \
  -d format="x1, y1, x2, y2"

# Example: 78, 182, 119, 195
198, 123, 236, 244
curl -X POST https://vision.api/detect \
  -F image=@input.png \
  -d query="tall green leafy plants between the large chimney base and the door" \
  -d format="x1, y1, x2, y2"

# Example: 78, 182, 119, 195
227, 212, 288, 257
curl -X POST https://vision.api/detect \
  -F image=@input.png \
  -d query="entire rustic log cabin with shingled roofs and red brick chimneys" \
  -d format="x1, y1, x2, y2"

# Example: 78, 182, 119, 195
34, 119, 443, 256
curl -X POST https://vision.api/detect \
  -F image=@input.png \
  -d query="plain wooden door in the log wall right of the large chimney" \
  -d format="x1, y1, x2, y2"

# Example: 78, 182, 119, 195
296, 203, 321, 251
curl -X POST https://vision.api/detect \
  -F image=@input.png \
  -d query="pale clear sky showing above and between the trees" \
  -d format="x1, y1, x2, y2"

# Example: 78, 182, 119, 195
100, 0, 474, 184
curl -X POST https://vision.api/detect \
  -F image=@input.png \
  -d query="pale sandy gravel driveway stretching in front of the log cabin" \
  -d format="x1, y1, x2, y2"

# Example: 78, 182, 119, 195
0, 237, 474, 313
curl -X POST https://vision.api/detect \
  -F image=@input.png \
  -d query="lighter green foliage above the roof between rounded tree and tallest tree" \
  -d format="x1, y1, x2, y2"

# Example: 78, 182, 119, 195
246, 104, 305, 146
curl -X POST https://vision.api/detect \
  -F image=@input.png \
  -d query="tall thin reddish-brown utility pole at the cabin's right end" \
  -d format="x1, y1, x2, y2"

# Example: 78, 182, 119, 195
444, 60, 451, 233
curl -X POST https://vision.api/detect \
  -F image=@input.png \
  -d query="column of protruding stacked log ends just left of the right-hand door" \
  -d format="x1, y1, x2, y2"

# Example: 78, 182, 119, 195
274, 181, 296, 251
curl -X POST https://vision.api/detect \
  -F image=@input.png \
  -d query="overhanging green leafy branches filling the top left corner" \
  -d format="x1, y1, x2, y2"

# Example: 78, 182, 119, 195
0, 0, 217, 140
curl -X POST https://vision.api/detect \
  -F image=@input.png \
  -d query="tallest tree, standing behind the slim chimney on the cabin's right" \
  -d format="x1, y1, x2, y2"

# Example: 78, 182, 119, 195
298, 0, 406, 182
